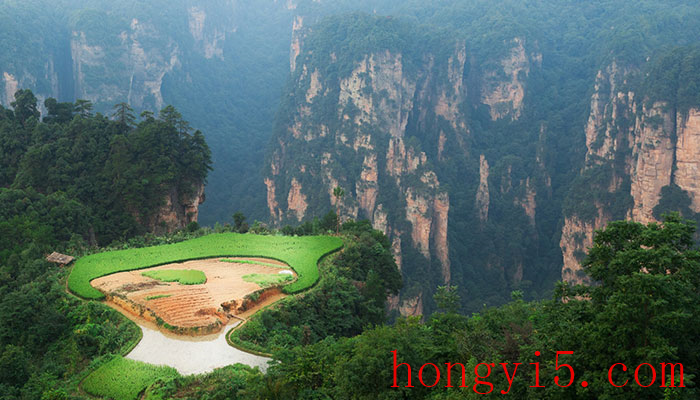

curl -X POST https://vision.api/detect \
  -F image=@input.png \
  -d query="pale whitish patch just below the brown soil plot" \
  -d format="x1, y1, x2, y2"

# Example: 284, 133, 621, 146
126, 324, 271, 375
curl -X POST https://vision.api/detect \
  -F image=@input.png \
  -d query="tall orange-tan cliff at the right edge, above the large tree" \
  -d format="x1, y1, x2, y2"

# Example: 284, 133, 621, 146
560, 57, 700, 283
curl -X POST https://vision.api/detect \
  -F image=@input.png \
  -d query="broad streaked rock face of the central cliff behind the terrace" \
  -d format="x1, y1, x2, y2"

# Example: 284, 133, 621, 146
265, 39, 469, 315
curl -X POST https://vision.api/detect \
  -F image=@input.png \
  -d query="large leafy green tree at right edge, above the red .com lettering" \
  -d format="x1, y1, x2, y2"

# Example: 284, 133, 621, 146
556, 213, 700, 398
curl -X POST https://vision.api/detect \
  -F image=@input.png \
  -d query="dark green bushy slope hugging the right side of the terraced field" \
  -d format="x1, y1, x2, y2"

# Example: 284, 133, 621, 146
229, 221, 401, 352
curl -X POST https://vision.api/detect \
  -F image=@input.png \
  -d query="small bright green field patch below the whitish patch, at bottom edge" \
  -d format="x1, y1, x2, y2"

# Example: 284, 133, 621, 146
81, 356, 179, 400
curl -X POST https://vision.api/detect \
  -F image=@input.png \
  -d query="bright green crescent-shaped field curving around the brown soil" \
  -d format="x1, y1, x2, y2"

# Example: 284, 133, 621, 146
68, 233, 343, 299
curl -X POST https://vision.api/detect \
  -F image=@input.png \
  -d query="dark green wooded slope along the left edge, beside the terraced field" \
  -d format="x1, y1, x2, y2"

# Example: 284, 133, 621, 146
0, 90, 208, 399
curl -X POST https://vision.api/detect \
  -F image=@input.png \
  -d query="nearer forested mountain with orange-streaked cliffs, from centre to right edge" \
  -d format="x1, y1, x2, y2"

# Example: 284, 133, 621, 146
265, 1, 700, 314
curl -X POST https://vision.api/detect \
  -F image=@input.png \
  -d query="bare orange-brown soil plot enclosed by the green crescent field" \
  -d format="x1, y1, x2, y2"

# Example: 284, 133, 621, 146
91, 257, 296, 334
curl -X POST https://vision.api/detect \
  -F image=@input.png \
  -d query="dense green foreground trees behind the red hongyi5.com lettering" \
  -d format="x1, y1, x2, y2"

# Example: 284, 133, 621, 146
141, 215, 700, 399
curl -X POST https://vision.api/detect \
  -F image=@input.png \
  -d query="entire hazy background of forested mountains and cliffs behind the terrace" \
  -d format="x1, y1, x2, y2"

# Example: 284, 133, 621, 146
0, 0, 700, 314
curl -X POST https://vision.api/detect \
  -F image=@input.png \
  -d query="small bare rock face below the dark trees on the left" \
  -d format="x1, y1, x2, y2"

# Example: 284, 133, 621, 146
142, 184, 204, 234
